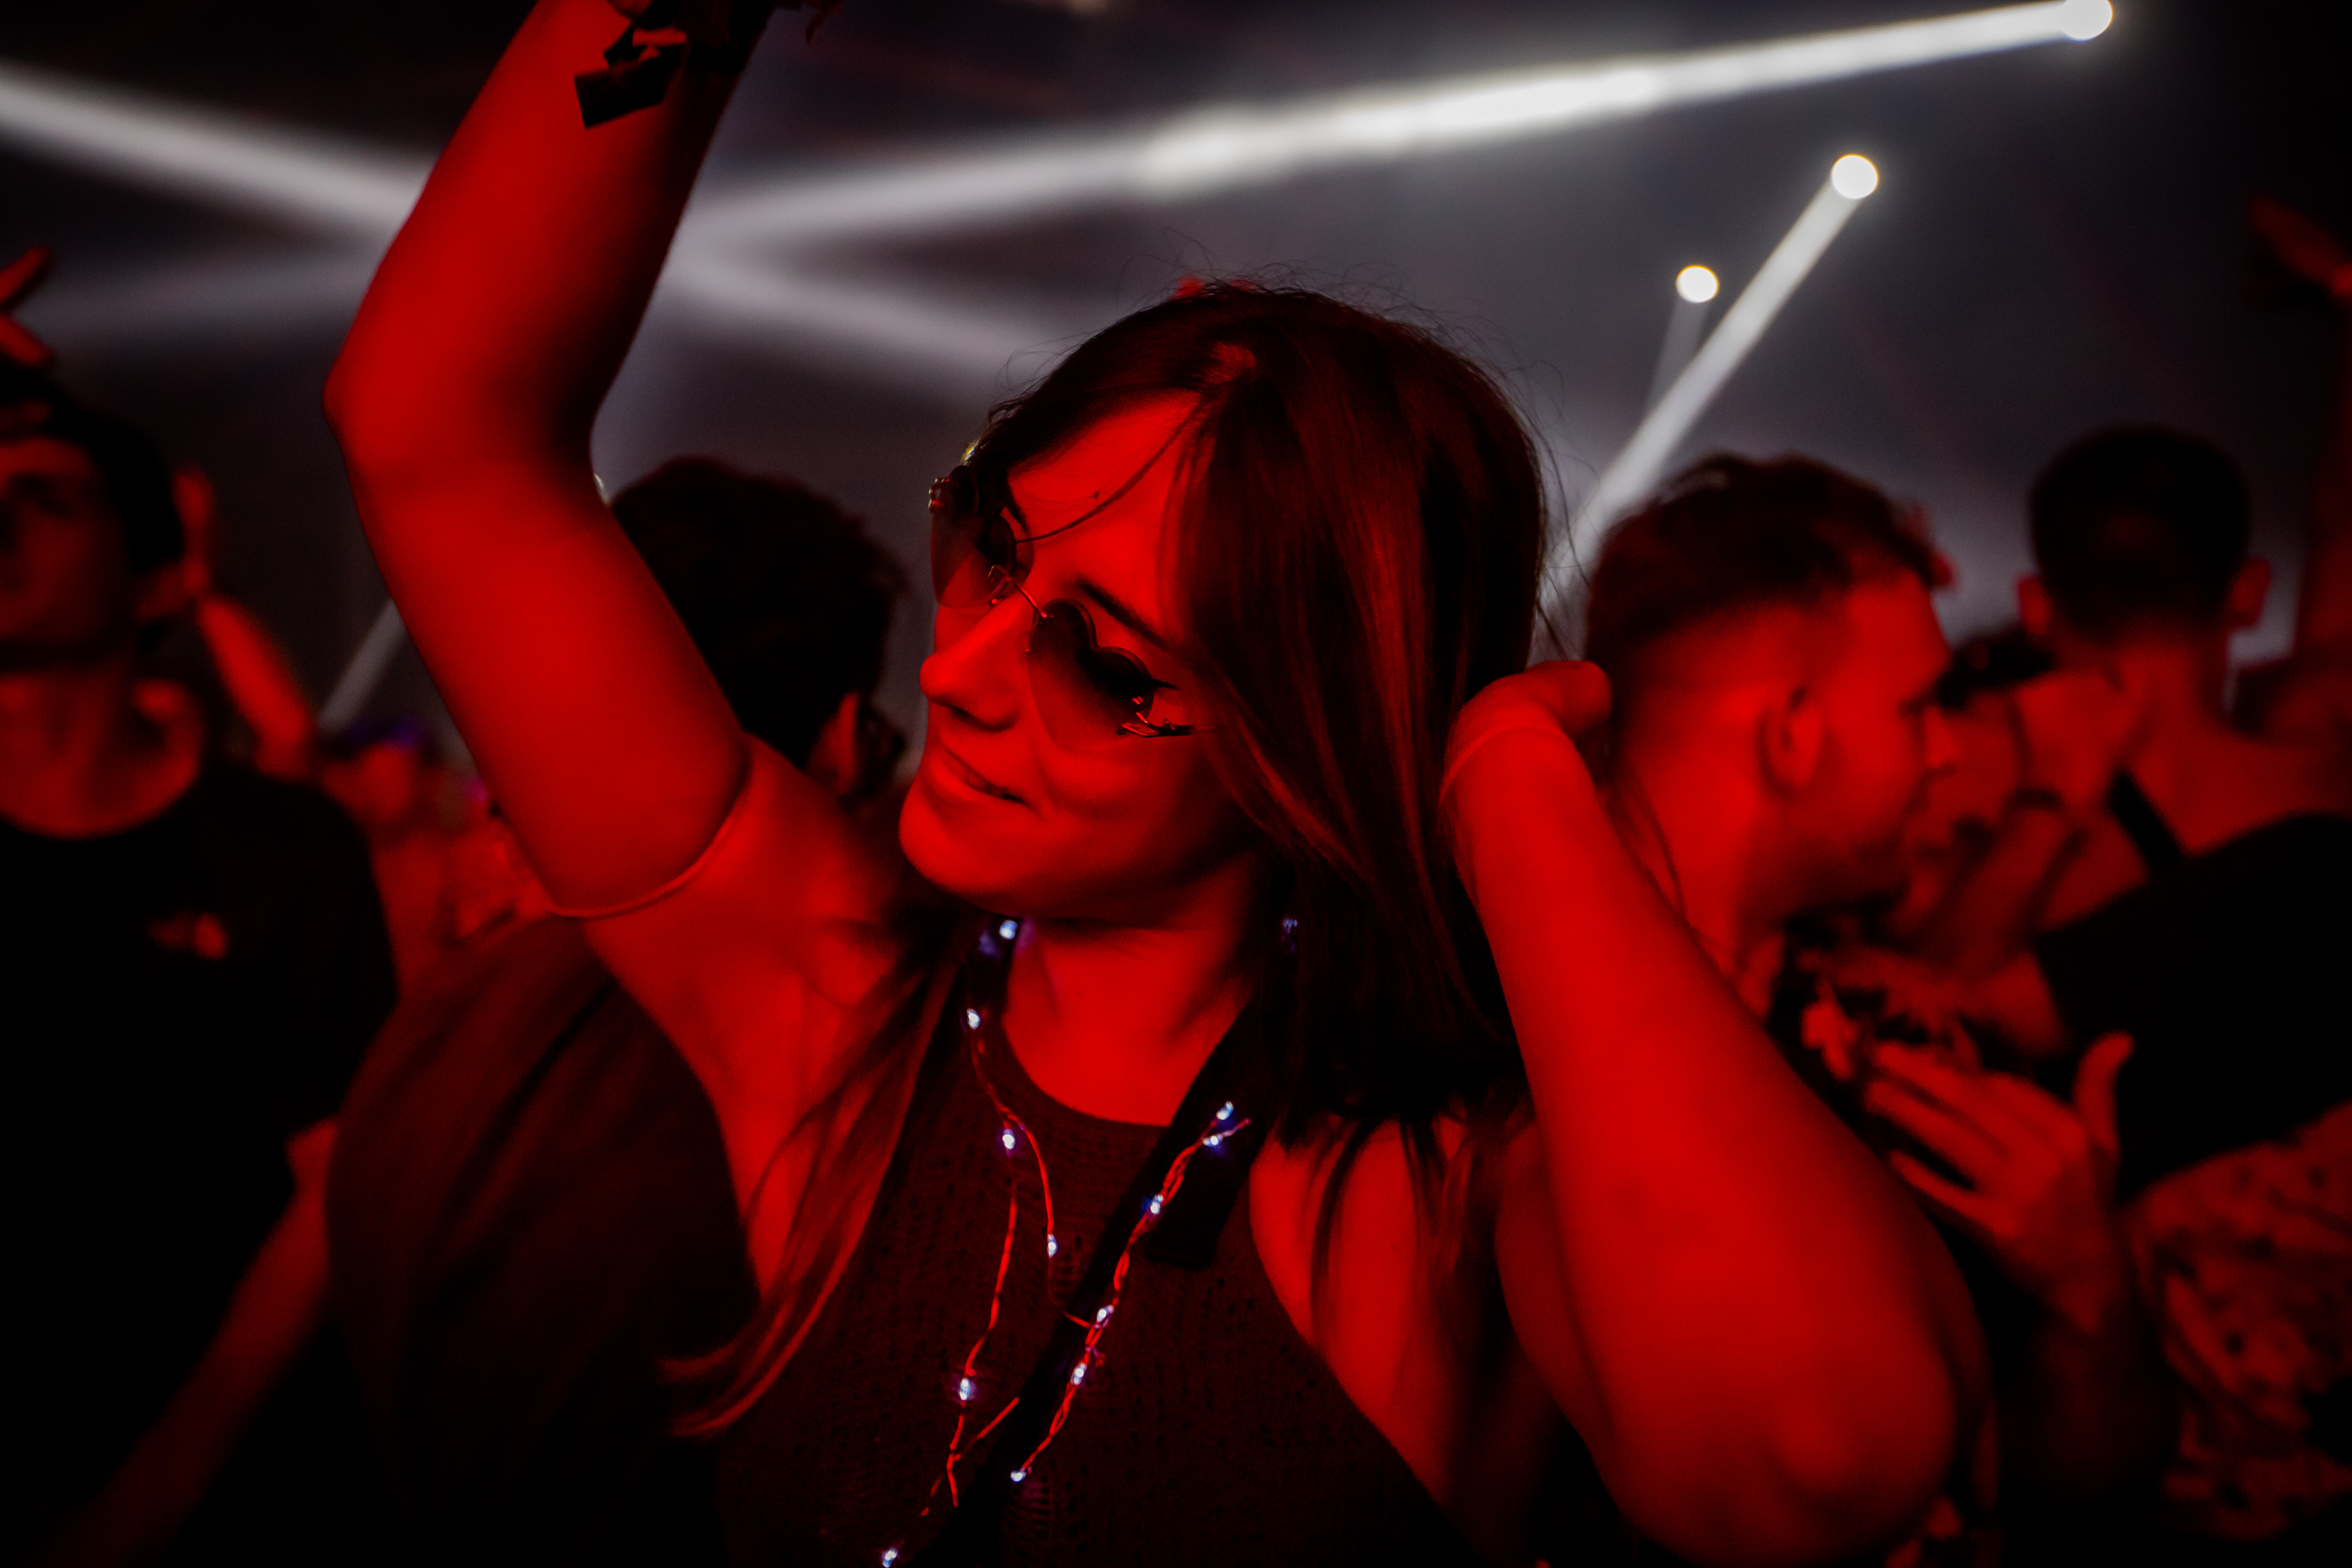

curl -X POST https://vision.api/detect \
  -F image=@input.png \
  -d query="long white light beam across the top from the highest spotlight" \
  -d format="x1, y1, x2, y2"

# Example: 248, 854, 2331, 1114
687, 0, 2112, 245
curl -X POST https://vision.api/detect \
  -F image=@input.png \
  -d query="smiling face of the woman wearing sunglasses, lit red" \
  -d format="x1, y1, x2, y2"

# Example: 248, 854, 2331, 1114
898, 397, 1254, 924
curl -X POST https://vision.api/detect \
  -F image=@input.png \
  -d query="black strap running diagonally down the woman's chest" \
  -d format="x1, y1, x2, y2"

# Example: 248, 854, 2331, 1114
908, 945, 1282, 1568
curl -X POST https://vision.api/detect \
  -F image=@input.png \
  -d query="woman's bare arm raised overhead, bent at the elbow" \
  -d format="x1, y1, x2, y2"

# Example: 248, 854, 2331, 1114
327, 0, 748, 907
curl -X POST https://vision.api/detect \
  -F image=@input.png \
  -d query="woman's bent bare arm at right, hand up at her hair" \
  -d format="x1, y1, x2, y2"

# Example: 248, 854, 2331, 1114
1444, 666, 1983, 1563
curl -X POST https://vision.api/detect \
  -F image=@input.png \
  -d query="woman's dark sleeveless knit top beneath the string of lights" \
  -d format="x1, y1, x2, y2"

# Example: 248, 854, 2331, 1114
720, 964, 1475, 1568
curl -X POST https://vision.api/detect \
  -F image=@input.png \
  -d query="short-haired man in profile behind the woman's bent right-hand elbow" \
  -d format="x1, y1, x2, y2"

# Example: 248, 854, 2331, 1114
1588, 456, 2161, 1549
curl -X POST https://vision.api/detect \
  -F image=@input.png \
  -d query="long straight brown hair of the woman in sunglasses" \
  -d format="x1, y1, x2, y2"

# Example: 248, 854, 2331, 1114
699, 285, 1543, 1427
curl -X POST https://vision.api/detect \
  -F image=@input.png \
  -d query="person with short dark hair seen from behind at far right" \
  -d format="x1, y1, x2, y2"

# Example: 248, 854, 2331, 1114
1879, 428, 2352, 1561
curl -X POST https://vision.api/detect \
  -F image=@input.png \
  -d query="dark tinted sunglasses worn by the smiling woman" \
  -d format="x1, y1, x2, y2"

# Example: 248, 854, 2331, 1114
931, 466, 1192, 750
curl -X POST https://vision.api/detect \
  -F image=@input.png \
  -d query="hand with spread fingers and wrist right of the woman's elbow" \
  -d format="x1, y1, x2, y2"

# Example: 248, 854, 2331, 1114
1865, 1034, 2173, 1504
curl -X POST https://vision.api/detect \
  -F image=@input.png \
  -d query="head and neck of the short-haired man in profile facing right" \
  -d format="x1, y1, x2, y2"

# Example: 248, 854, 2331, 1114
1585, 456, 1952, 1013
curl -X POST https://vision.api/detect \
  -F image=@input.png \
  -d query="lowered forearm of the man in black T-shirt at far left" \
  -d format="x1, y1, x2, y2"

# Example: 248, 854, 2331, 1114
35, 1121, 334, 1568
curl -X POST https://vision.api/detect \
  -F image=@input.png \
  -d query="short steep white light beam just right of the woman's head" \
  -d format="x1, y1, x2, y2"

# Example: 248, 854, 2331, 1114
1543, 153, 1877, 612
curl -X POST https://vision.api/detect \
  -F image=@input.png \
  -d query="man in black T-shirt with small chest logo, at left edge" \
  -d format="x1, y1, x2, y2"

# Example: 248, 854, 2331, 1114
0, 263, 393, 1563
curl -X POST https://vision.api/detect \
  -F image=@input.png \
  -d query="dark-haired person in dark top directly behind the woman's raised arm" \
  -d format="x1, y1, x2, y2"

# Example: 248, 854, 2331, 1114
329, 459, 903, 1566
